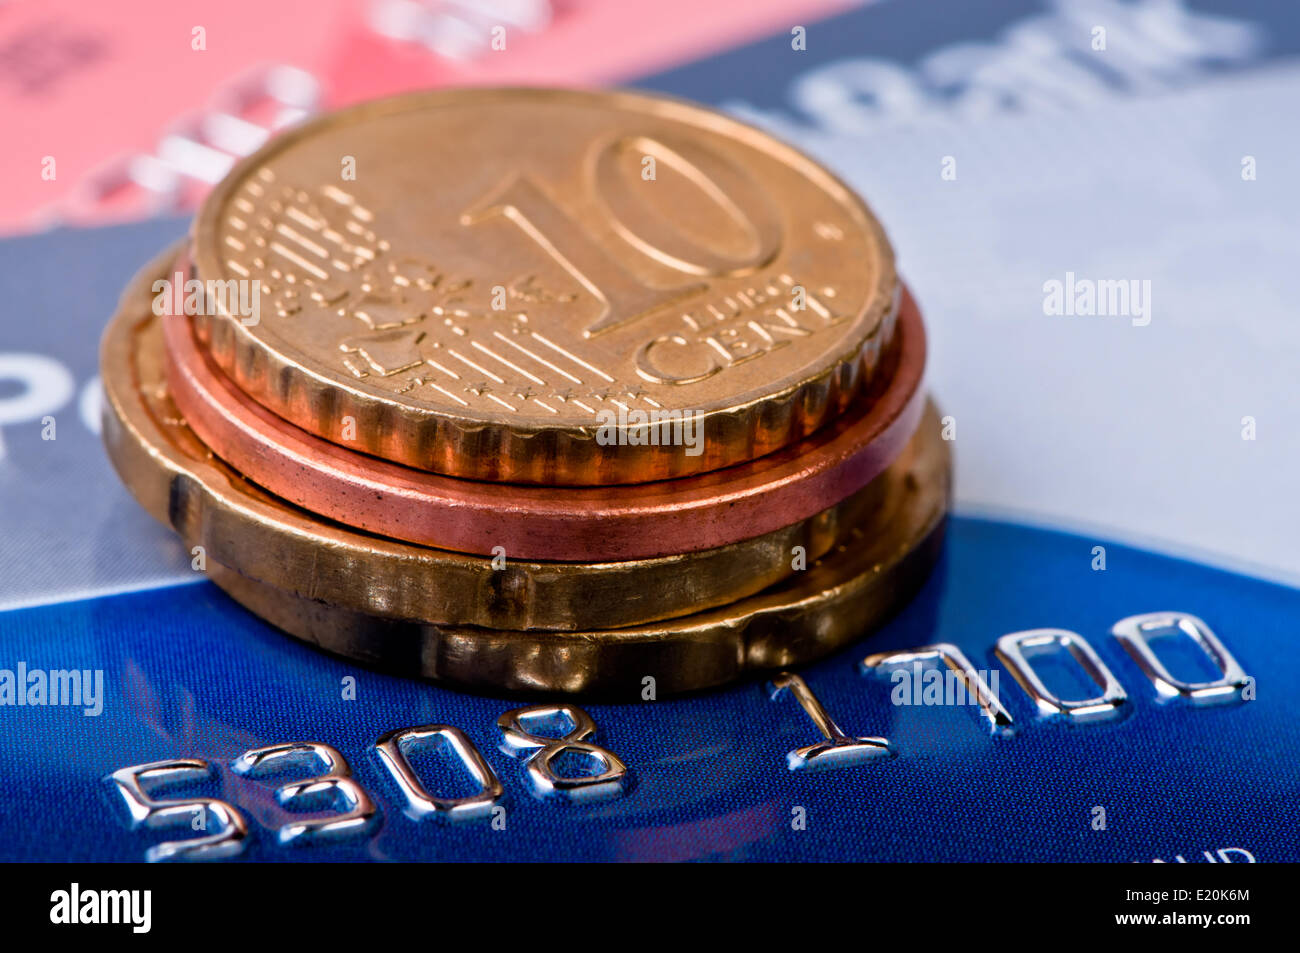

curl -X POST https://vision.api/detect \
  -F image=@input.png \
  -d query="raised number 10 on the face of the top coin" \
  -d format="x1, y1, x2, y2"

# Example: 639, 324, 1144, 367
460, 137, 781, 337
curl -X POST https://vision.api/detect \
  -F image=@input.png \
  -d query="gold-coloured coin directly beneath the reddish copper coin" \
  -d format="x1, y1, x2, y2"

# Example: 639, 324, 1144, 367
101, 252, 887, 629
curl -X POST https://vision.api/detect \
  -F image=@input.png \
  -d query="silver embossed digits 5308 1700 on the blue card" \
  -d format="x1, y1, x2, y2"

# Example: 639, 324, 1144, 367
105, 612, 1253, 861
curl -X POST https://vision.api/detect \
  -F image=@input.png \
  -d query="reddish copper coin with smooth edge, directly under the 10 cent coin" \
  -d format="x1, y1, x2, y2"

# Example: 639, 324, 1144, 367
163, 254, 926, 562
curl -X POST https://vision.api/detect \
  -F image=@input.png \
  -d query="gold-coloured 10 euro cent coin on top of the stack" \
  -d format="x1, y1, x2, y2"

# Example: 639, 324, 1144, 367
192, 88, 897, 485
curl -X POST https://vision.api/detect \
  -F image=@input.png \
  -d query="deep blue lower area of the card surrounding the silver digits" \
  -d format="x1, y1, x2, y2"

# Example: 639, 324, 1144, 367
0, 519, 1300, 862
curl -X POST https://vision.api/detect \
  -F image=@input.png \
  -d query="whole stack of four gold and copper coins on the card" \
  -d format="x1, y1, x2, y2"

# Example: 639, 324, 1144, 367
101, 88, 950, 697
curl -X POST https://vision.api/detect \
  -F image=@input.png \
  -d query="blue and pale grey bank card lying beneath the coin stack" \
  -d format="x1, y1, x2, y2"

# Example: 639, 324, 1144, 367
0, 0, 1300, 863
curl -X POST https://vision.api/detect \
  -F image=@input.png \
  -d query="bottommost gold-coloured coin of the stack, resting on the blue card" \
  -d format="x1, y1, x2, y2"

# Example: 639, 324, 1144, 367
209, 397, 952, 699
